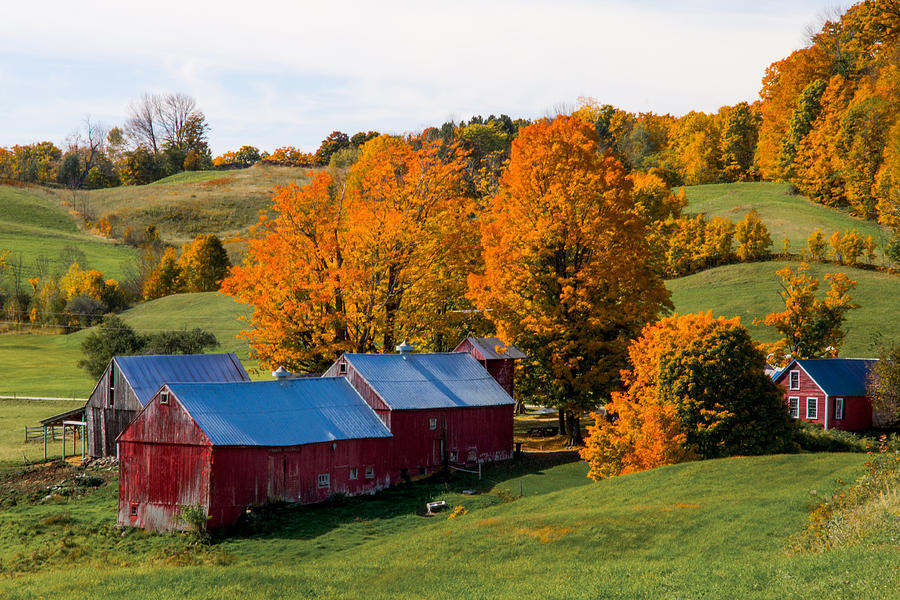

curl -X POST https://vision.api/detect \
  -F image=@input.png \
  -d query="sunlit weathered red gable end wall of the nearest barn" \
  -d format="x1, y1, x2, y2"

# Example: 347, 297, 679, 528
118, 394, 211, 531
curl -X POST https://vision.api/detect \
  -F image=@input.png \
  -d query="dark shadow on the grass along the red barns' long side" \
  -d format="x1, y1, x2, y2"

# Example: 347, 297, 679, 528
221, 451, 579, 543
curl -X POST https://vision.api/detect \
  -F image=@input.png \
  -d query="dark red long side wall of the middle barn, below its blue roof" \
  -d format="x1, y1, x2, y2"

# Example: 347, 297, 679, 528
391, 405, 513, 477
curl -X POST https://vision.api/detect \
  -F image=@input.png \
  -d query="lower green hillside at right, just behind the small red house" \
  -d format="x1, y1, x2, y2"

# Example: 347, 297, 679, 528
666, 261, 900, 357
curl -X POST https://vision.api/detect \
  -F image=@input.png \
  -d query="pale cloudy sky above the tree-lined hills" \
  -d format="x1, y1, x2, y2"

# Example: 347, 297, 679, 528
0, 0, 846, 155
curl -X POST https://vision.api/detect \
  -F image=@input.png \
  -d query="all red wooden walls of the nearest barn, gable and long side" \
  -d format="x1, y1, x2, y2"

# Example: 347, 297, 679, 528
118, 384, 391, 531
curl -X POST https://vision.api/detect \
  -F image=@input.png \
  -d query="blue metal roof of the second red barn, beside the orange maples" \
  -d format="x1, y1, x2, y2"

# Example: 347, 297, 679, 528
344, 352, 515, 410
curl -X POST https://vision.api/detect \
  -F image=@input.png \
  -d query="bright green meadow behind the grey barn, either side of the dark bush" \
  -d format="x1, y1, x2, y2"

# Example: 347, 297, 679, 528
0, 292, 258, 398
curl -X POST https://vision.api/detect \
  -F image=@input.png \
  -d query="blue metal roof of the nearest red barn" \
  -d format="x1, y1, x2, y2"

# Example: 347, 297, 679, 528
169, 377, 391, 446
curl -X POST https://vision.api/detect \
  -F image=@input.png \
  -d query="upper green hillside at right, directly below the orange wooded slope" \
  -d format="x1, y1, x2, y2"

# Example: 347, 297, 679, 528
685, 182, 891, 253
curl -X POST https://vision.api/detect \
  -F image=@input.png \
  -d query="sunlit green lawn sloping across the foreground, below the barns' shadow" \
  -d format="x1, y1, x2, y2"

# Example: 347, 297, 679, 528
0, 454, 900, 600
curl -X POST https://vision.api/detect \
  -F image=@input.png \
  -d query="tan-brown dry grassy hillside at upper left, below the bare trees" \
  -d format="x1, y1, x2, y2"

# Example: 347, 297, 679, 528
81, 165, 318, 243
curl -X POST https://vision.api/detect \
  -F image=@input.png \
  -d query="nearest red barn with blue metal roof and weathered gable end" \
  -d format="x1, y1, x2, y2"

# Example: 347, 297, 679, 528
118, 377, 392, 531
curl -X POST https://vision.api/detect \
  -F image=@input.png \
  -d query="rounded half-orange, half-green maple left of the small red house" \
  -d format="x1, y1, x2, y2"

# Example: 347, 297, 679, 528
581, 311, 792, 479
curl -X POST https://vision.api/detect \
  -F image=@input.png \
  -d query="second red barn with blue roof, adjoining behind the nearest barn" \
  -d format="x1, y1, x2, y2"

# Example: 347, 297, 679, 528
325, 346, 515, 479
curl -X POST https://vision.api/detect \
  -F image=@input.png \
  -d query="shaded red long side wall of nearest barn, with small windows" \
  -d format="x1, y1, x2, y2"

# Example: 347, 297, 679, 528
209, 438, 391, 528
